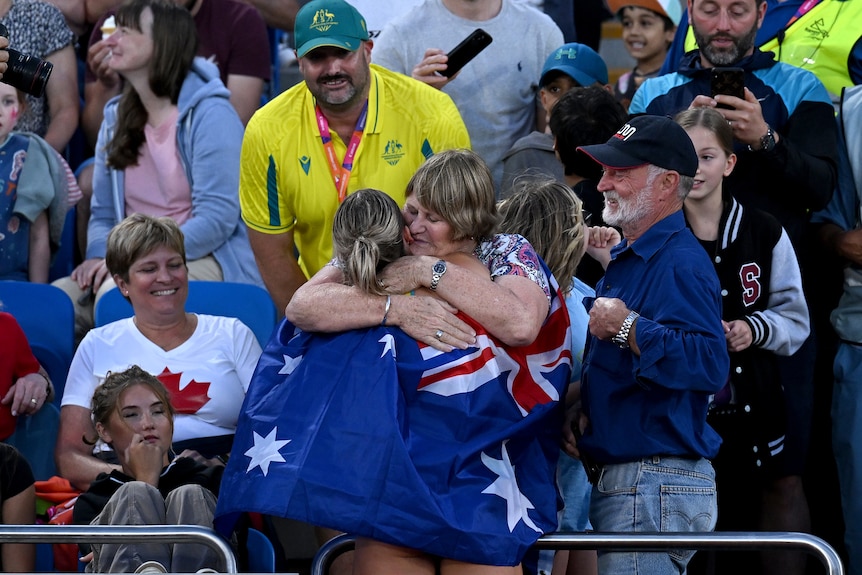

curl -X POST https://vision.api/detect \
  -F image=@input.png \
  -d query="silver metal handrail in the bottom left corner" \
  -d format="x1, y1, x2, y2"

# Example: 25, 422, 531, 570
0, 525, 237, 573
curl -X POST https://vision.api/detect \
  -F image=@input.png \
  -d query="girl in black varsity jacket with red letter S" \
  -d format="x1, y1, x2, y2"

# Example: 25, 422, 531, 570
676, 108, 809, 530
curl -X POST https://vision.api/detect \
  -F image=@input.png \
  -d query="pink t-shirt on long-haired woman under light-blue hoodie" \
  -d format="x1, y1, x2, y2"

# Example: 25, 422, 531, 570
125, 108, 192, 225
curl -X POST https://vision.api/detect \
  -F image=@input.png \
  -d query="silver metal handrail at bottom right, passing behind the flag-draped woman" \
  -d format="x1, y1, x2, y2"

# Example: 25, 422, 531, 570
311, 531, 844, 575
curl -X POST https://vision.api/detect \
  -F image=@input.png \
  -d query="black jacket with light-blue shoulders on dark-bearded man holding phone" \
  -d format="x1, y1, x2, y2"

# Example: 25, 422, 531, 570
629, 49, 838, 268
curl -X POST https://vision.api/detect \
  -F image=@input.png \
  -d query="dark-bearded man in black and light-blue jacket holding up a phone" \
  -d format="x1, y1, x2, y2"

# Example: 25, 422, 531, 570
629, 0, 837, 574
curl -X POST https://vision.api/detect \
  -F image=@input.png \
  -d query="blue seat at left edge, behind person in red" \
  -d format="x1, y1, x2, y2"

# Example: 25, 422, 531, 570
0, 281, 75, 406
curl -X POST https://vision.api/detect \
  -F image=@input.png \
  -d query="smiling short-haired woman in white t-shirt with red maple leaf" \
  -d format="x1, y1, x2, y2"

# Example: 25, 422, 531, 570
56, 214, 261, 489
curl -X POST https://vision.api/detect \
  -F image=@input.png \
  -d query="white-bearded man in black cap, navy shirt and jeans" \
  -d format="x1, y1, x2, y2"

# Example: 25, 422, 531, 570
565, 116, 730, 575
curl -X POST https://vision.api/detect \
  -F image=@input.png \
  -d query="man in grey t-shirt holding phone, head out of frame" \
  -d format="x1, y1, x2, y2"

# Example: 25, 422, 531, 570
373, 0, 563, 194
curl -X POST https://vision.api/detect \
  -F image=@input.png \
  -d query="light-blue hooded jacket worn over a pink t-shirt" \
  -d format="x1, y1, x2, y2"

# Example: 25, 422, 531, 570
87, 58, 263, 286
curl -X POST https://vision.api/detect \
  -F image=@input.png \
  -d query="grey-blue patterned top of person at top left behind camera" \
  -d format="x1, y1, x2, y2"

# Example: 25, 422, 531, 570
0, 0, 75, 136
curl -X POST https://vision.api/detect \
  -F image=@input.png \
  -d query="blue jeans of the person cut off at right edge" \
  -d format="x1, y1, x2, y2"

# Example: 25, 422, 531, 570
832, 343, 862, 575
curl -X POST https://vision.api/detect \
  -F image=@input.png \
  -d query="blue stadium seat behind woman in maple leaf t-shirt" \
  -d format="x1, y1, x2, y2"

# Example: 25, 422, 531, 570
94, 280, 276, 347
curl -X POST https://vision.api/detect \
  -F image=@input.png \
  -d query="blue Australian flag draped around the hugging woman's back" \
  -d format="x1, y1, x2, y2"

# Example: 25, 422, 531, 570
216, 274, 571, 565
